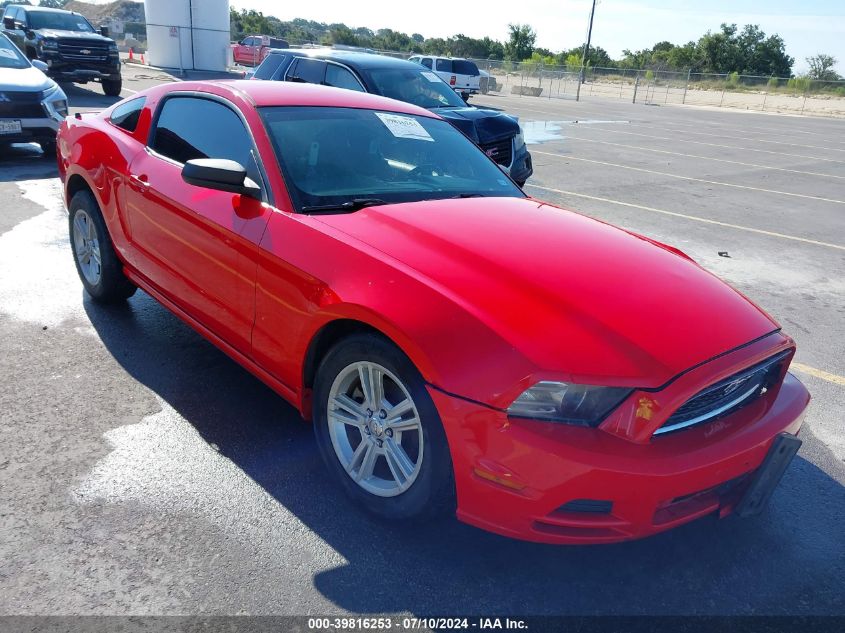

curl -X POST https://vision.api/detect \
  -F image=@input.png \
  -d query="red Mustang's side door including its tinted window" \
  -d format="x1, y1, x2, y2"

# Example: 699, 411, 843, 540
126, 93, 269, 354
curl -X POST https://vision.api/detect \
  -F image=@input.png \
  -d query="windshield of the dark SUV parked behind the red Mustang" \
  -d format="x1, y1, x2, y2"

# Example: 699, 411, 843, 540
362, 68, 466, 109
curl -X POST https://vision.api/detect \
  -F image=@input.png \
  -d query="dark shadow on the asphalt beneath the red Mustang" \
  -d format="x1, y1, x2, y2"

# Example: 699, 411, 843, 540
83, 292, 845, 615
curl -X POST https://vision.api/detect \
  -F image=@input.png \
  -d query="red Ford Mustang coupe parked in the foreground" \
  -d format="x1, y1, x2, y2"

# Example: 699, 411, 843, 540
58, 82, 809, 543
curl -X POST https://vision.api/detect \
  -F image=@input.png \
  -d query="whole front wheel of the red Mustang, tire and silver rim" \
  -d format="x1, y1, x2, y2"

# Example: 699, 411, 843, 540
313, 334, 455, 520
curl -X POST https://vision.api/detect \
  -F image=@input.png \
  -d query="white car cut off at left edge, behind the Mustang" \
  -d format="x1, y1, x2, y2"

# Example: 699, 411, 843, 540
0, 33, 67, 158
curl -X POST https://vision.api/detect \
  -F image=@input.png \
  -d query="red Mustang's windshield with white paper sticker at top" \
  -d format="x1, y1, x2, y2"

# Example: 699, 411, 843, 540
260, 106, 525, 213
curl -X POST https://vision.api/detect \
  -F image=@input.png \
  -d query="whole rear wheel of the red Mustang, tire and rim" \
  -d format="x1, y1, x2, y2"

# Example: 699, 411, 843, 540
68, 191, 137, 303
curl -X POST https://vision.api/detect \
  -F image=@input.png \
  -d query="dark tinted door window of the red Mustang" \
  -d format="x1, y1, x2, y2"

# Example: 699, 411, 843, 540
152, 96, 261, 182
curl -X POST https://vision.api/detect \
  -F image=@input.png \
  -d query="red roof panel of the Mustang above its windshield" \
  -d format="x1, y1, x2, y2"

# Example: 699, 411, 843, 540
168, 79, 439, 119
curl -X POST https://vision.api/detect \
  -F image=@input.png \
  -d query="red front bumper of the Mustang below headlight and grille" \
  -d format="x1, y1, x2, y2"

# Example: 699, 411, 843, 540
429, 374, 810, 543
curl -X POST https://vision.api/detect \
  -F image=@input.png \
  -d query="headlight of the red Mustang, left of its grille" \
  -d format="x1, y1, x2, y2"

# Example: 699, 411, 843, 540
508, 381, 632, 427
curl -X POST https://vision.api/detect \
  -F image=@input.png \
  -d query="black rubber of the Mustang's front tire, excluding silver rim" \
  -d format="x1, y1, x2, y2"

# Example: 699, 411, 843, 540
313, 334, 454, 520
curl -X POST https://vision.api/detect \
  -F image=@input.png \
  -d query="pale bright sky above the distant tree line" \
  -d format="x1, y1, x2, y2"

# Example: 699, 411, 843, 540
231, 0, 845, 75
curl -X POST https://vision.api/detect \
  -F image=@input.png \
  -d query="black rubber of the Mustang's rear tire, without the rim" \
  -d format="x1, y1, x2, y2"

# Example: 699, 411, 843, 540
68, 191, 135, 303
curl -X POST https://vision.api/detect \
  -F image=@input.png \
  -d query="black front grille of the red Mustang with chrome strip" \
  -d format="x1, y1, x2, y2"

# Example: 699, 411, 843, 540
654, 352, 789, 435
